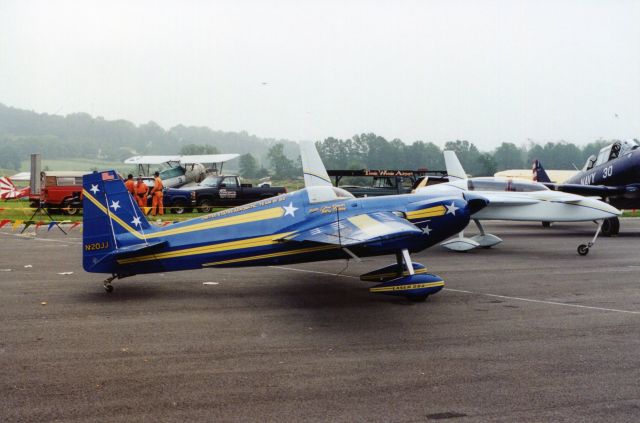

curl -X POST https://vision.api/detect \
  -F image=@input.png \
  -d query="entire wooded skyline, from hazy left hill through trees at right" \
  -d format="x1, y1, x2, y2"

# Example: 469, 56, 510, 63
0, 104, 632, 179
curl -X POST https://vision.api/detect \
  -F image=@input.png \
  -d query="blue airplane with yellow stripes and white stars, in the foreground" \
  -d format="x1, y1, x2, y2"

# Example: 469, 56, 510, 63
82, 143, 487, 301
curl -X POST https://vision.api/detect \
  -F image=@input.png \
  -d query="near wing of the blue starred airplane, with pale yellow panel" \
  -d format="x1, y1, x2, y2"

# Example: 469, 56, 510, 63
283, 212, 422, 247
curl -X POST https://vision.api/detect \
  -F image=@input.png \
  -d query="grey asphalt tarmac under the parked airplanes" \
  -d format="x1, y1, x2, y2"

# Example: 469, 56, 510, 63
0, 219, 640, 422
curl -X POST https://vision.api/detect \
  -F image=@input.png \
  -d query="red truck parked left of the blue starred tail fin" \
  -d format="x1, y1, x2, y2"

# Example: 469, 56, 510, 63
29, 171, 91, 215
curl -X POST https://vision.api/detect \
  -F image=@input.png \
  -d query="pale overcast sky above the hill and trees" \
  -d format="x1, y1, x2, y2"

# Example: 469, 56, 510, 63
0, 0, 640, 150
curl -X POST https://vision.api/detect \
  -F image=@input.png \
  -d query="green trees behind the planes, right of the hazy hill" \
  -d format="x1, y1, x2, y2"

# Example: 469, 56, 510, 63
240, 133, 615, 179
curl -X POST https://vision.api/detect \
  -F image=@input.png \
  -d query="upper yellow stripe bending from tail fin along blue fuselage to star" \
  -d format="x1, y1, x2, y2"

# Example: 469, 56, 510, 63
82, 190, 284, 239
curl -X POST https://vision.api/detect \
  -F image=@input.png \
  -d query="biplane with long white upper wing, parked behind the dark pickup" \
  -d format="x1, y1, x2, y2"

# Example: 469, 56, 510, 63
124, 154, 240, 188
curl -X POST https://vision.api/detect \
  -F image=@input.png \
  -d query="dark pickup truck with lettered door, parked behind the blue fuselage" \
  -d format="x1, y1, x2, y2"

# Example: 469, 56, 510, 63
164, 176, 287, 214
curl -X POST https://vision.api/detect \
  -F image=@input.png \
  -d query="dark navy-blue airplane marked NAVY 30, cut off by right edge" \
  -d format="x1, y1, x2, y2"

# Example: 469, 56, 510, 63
533, 140, 640, 235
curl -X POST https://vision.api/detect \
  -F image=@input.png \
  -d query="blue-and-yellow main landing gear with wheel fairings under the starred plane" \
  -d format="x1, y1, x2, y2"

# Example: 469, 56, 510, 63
360, 249, 444, 302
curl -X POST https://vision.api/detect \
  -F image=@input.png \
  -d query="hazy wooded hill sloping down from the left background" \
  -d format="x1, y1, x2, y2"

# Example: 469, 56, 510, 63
0, 103, 298, 167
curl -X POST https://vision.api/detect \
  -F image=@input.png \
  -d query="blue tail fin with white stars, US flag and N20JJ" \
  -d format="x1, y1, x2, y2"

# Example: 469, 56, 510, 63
82, 170, 154, 273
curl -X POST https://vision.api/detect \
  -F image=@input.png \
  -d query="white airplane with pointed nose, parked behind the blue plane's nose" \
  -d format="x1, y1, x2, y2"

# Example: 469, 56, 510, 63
416, 151, 622, 256
